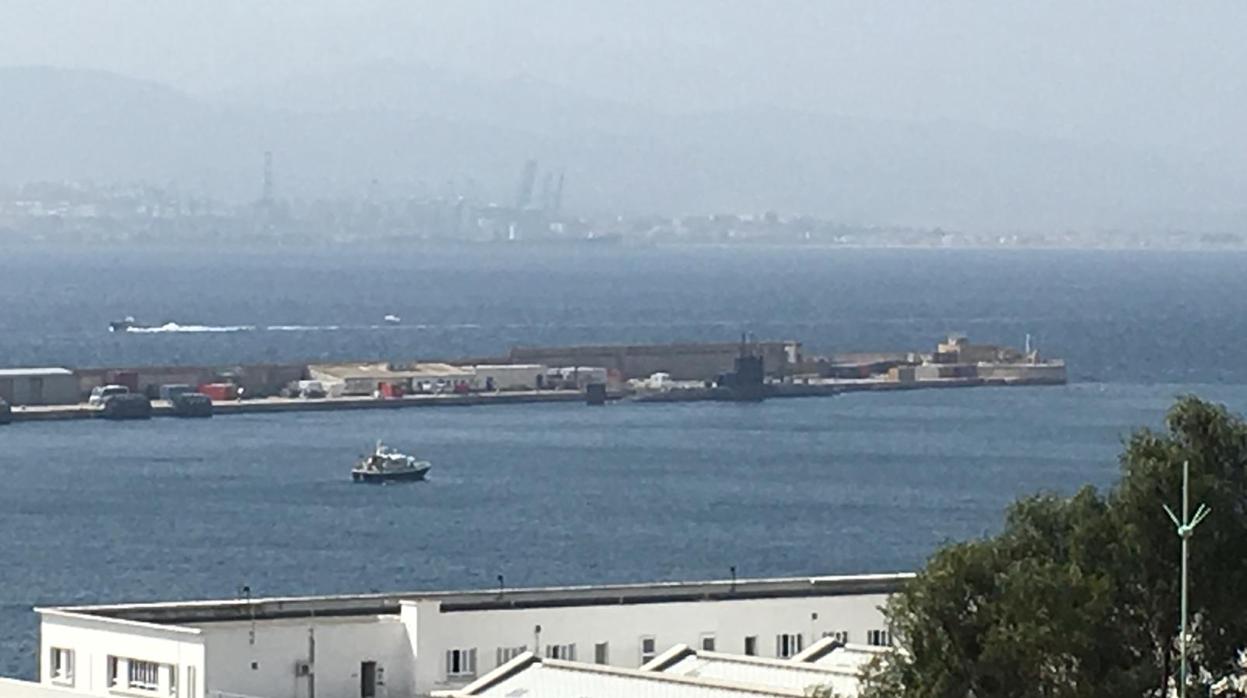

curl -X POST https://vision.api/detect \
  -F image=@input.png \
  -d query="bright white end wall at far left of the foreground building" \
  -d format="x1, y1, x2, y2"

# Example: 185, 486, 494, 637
39, 611, 205, 698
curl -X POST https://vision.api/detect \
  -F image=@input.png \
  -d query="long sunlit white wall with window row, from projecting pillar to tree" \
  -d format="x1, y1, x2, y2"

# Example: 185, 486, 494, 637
402, 595, 888, 696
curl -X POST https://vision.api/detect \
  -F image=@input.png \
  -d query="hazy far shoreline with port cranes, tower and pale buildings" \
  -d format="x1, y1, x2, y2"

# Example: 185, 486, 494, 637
0, 163, 1247, 248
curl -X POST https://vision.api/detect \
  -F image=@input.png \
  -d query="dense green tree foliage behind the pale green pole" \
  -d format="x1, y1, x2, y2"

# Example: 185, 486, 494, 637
864, 396, 1247, 698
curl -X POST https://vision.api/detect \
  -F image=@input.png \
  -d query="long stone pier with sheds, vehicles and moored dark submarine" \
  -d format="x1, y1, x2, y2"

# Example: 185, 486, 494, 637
0, 335, 1067, 423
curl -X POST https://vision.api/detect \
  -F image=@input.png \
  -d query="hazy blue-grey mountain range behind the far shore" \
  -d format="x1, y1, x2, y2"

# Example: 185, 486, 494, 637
0, 65, 1247, 231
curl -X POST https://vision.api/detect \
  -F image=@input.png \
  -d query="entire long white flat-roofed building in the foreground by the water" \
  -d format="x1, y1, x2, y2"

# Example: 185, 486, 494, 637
21, 575, 909, 698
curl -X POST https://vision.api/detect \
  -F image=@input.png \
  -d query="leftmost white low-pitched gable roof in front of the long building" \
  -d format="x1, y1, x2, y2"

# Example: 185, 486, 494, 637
435, 652, 807, 698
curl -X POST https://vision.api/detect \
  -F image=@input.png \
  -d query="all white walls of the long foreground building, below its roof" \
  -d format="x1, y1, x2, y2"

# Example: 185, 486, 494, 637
40, 580, 888, 698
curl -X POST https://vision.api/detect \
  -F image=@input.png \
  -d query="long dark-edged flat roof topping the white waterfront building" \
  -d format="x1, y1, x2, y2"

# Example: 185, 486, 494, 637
36, 572, 913, 624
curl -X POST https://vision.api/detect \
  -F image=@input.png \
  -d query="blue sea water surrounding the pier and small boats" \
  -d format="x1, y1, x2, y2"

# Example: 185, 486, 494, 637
0, 247, 1247, 677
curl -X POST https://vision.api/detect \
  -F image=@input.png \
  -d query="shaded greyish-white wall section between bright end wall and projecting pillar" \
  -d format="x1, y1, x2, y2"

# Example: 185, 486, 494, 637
195, 616, 413, 698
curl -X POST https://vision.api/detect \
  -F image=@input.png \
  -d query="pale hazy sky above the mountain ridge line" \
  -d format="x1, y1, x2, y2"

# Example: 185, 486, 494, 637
7, 0, 1247, 157
